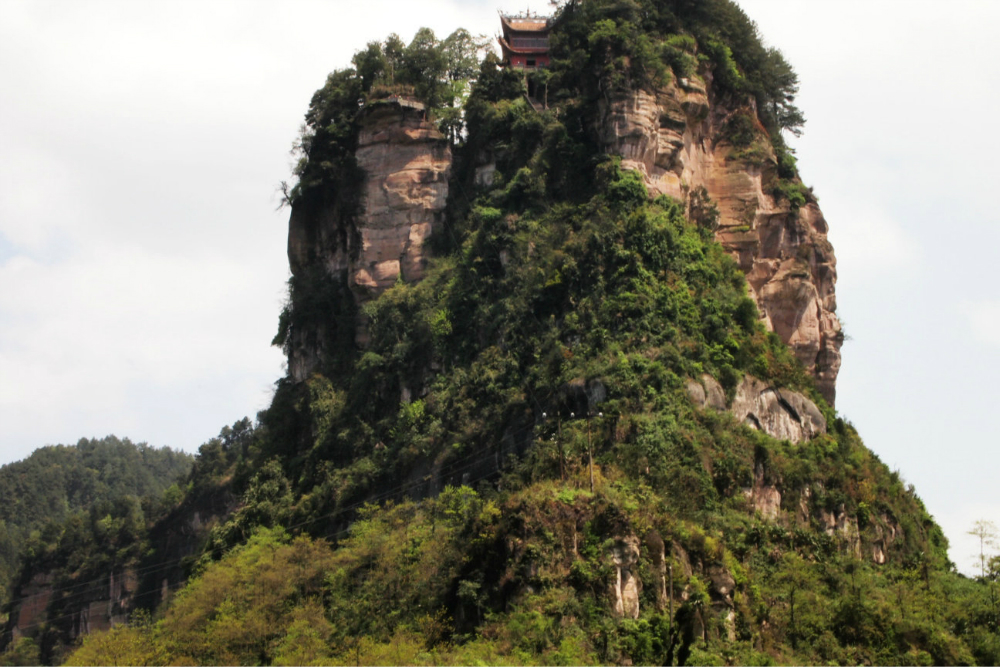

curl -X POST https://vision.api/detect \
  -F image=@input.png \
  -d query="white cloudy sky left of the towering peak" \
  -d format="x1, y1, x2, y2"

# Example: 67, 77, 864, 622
0, 0, 549, 462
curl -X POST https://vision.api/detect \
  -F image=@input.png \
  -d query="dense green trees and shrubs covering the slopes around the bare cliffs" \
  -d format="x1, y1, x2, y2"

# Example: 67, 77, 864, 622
0, 0, 1000, 665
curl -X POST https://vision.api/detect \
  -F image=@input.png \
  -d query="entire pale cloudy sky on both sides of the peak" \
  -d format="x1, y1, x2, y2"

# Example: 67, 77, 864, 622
0, 0, 1000, 573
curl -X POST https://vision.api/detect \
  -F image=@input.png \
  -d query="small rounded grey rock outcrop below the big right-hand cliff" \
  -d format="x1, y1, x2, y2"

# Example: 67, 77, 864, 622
687, 374, 826, 443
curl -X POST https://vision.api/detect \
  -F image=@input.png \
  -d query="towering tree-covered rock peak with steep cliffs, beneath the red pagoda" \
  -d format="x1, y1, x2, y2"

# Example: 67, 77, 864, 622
15, 0, 1000, 664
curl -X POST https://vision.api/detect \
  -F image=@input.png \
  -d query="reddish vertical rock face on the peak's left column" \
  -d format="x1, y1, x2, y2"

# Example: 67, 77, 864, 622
288, 97, 452, 382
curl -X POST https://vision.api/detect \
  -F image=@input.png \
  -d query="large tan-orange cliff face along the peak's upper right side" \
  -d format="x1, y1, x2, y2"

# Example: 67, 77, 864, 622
598, 72, 843, 404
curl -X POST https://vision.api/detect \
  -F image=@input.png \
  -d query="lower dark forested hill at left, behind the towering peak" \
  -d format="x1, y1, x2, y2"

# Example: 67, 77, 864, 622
0, 428, 233, 664
